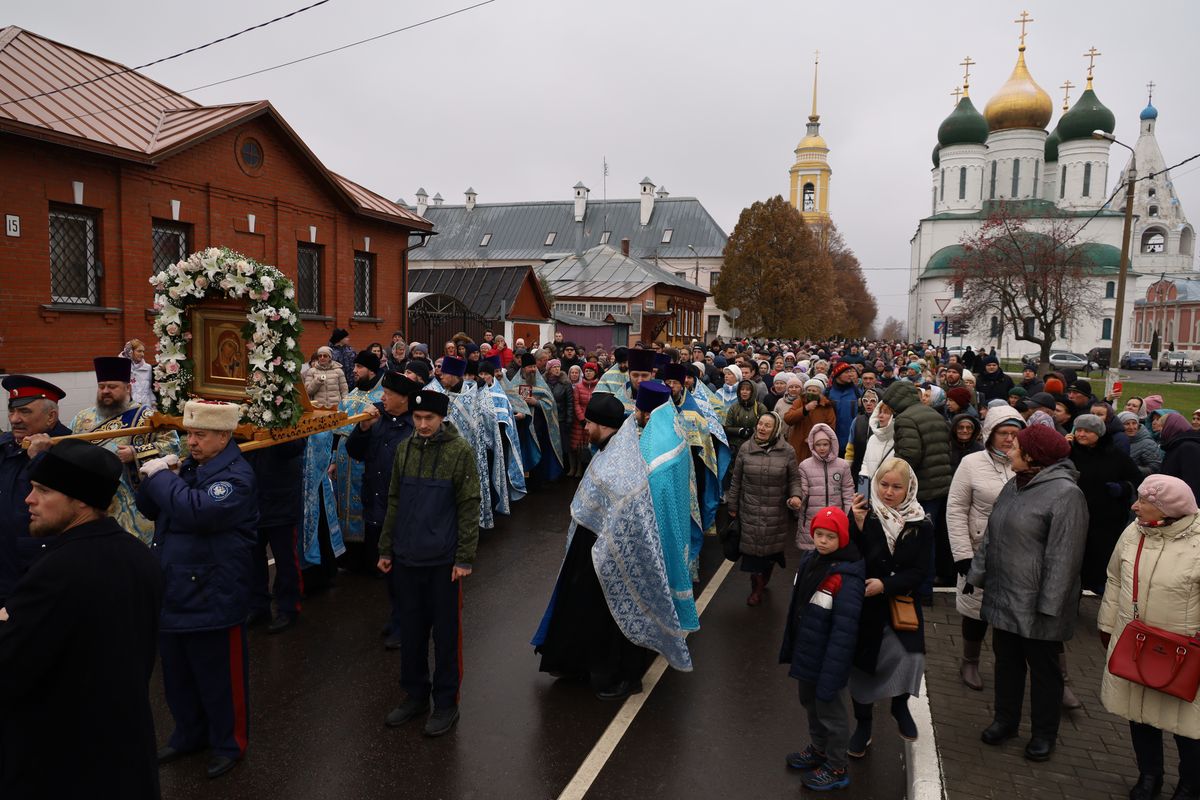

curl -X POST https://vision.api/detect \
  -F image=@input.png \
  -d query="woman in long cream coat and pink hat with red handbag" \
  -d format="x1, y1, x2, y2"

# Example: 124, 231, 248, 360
1097, 475, 1200, 800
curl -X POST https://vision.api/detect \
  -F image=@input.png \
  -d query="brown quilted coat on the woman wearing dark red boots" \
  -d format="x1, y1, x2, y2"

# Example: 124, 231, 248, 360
725, 438, 800, 555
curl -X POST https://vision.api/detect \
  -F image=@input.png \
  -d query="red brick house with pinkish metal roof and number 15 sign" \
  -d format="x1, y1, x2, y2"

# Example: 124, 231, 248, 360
0, 28, 432, 403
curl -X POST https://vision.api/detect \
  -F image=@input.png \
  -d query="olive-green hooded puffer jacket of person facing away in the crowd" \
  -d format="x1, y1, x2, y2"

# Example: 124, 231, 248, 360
883, 380, 954, 500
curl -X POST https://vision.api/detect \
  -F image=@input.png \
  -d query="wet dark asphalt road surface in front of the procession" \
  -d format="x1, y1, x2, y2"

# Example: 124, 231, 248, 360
151, 480, 904, 800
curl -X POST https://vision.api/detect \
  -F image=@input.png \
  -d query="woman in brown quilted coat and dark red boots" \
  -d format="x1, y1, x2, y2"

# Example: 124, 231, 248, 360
725, 411, 800, 606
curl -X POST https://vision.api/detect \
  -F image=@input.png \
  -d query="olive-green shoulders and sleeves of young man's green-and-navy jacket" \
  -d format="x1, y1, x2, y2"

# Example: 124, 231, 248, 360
379, 422, 479, 566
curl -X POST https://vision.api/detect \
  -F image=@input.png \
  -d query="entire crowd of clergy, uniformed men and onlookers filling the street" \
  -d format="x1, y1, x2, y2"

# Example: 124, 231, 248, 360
0, 329, 1200, 799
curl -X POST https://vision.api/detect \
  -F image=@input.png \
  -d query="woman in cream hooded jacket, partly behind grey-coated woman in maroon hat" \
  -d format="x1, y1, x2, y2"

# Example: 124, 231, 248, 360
946, 405, 1025, 692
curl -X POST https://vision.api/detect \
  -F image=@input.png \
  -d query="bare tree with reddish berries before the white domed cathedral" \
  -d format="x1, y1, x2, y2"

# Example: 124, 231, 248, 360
948, 204, 1100, 372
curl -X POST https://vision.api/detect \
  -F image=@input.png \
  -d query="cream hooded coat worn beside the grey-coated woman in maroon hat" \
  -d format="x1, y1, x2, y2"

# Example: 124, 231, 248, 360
946, 407, 1021, 619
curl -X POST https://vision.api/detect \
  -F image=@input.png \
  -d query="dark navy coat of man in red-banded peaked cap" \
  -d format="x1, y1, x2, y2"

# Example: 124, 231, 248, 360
0, 422, 71, 606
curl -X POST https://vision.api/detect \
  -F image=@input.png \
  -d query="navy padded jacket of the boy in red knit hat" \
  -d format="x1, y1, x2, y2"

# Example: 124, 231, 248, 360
779, 547, 866, 700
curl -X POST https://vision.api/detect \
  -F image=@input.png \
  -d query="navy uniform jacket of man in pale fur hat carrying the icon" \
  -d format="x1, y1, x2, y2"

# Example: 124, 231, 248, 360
138, 440, 258, 633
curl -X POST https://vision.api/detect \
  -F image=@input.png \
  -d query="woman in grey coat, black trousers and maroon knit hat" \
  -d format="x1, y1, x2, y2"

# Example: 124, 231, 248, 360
962, 425, 1087, 762
